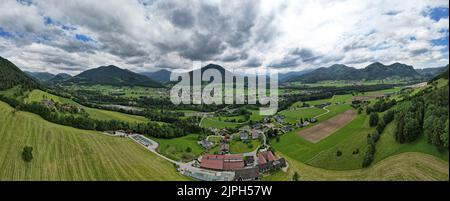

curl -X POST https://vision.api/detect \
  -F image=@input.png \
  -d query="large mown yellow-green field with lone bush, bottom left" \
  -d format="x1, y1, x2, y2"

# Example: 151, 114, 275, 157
0, 102, 188, 180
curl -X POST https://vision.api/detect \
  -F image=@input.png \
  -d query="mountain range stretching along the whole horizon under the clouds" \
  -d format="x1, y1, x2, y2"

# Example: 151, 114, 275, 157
0, 57, 448, 88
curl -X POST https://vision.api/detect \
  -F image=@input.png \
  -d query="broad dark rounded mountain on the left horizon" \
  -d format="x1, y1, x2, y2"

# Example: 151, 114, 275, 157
64, 65, 162, 87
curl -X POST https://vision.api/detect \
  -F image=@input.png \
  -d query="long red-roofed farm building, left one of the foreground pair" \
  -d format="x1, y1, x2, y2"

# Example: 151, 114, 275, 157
200, 154, 245, 171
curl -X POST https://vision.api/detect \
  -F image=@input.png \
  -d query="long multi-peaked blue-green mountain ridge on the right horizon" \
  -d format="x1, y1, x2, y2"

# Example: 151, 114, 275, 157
287, 62, 420, 83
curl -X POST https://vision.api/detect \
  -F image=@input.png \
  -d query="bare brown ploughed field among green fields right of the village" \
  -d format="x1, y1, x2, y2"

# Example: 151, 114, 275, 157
298, 110, 356, 143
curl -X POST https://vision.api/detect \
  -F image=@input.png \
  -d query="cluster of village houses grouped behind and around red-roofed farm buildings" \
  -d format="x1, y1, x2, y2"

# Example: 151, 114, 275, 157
190, 110, 327, 181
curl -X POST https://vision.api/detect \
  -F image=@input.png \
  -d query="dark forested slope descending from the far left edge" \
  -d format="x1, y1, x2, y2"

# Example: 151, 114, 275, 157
0, 57, 39, 90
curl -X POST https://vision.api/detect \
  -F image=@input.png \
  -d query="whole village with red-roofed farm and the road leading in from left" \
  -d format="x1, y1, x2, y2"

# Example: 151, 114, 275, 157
101, 103, 330, 181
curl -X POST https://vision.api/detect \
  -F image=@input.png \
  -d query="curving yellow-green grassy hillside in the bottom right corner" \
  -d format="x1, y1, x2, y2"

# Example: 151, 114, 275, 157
264, 152, 449, 181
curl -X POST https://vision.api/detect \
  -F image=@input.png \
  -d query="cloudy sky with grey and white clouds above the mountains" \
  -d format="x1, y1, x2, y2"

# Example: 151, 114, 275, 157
0, 0, 449, 74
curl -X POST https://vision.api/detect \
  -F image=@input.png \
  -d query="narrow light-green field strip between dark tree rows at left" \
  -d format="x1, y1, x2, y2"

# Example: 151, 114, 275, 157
25, 89, 149, 123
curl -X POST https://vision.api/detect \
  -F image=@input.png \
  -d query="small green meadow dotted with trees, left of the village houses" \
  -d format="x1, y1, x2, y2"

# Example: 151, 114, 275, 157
151, 134, 203, 161
